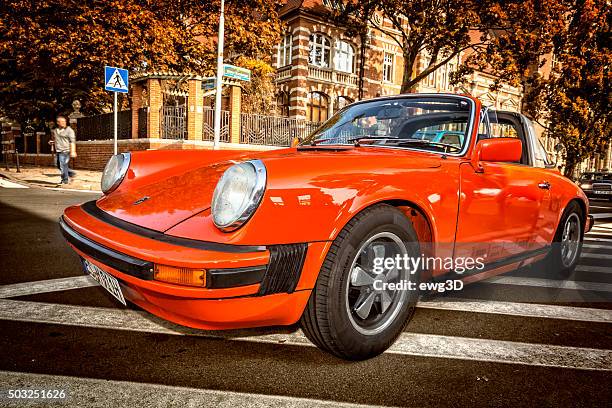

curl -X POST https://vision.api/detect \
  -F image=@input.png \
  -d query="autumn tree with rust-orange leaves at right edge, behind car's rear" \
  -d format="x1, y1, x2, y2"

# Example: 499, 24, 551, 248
477, 0, 612, 177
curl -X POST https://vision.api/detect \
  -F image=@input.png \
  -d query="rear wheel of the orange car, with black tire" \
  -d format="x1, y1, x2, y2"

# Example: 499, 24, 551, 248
546, 201, 584, 278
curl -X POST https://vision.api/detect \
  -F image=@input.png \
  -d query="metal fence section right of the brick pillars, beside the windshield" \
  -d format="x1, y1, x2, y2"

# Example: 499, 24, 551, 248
240, 113, 319, 146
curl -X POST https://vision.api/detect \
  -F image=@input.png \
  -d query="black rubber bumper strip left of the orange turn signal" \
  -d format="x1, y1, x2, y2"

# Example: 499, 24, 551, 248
59, 217, 153, 280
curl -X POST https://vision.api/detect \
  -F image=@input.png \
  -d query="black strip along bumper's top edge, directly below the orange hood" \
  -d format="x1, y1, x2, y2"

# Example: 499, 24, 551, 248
81, 200, 266, 253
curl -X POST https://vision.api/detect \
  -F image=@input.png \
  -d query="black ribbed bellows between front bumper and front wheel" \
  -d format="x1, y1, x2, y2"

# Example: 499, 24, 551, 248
259, 244, 308, 295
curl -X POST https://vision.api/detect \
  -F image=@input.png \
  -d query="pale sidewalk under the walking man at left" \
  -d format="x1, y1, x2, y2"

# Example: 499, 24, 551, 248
0, 166, 102, 191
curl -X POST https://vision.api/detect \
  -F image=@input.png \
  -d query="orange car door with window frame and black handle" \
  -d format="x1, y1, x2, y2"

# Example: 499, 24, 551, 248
455, 113, 548, 264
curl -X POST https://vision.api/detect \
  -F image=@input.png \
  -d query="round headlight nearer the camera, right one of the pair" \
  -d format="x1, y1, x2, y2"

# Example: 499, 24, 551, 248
211, 160, 266, 231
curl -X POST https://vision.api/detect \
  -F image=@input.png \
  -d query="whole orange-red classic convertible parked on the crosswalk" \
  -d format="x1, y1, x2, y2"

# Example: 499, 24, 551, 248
60, 94, 593, 360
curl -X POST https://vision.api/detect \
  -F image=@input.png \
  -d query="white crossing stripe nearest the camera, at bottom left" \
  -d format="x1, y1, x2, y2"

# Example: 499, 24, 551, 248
0, 371, 374, 408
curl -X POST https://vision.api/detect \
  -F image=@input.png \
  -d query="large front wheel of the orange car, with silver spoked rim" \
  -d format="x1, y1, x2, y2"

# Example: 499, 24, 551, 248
301, 204, 420, 360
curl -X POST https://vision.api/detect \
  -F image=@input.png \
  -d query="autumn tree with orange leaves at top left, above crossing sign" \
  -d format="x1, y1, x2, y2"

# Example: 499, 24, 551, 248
0, 0, 280, 126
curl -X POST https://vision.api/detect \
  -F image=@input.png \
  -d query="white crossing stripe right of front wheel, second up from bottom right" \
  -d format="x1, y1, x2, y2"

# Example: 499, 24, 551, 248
417, 298, 612, 323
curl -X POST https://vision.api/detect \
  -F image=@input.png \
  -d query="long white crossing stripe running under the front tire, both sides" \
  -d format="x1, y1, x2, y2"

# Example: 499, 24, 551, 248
0, 299, 612, 371
